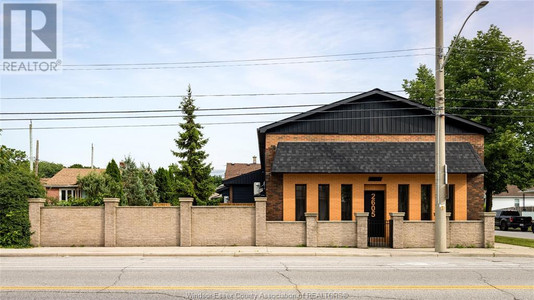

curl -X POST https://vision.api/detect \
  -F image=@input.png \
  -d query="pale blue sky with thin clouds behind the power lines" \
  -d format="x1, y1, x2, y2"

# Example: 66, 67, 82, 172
0, 0, 534, 174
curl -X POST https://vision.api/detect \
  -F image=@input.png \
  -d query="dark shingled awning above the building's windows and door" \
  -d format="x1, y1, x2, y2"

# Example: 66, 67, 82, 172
272, 142, 487, 174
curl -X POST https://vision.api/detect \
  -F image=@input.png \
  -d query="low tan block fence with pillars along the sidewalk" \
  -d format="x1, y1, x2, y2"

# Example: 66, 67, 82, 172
28, 197, 495, 248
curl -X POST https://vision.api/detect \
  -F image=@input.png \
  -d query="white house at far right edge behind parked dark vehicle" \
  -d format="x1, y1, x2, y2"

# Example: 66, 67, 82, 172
492, 185, 534, 216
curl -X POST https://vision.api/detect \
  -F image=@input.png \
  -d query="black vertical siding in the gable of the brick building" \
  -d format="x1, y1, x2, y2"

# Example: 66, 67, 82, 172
269, 95, 473, 134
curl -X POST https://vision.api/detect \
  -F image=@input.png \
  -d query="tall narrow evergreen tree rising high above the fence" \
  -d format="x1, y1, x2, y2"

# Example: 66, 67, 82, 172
172, 86, 215, 205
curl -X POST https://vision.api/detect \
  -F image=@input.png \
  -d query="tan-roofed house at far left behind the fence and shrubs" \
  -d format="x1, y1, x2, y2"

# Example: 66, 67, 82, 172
43, 168, 106, 201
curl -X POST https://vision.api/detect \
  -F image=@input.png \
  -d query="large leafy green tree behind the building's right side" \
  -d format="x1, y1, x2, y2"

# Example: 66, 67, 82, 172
403, 25, 534, 211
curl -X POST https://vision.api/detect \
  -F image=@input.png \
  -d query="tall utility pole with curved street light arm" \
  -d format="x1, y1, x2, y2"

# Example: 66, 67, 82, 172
434, 0, 488, 252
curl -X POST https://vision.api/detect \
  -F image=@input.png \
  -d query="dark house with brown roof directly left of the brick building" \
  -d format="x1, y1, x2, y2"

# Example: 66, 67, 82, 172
217, 156, 264, 203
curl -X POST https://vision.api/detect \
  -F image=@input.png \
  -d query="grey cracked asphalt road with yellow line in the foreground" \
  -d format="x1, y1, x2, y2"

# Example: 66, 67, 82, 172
0, 256, 534, 300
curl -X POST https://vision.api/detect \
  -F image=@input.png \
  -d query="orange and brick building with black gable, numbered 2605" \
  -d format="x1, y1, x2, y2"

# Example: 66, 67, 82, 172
258, 89, 491, 222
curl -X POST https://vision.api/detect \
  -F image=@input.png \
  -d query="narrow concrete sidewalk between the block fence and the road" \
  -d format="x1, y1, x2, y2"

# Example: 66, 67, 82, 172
0, 243, 534, 258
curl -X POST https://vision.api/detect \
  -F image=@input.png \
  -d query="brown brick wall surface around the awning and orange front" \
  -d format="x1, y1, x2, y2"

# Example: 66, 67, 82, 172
265, 134, 484, 221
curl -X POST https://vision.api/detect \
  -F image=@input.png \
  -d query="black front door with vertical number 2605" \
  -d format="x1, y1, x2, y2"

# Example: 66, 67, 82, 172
364, 191, 386, 237
